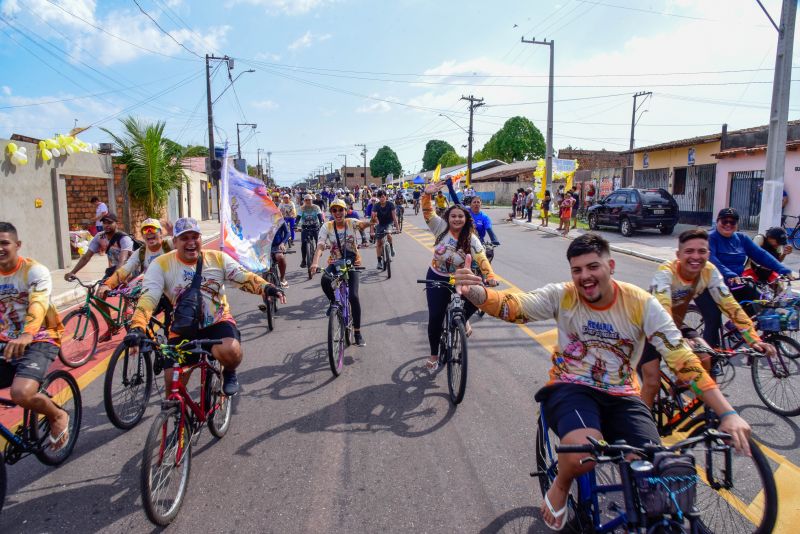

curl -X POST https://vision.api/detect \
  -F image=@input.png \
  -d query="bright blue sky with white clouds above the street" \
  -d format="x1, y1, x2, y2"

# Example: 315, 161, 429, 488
0, 0, 800, 185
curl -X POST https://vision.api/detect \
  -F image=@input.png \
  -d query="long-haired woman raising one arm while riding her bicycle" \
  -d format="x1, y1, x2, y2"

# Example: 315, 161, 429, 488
422, 182, 498, 370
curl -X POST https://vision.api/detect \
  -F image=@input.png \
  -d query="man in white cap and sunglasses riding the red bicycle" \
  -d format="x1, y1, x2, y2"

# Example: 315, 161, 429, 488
125, 217, 286, 396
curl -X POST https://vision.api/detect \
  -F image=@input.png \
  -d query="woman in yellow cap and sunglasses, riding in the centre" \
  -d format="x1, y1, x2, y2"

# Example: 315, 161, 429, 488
311, 199, 369, 347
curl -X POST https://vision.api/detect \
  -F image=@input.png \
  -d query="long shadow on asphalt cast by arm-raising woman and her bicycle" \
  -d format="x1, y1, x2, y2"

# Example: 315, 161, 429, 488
231, 358, 455, 456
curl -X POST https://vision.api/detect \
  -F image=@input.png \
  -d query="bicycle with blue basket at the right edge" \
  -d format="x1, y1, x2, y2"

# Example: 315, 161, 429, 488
684, 298, 800, 416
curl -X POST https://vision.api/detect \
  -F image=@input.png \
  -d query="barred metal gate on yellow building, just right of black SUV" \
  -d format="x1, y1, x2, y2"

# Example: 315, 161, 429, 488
672, 164, 717, 226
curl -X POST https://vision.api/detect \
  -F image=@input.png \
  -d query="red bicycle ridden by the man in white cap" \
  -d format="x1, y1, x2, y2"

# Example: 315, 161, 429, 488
139, 339, 232, 526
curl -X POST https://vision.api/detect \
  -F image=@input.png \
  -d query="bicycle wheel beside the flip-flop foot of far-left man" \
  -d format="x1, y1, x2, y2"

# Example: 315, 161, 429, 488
29, 370, 83, 465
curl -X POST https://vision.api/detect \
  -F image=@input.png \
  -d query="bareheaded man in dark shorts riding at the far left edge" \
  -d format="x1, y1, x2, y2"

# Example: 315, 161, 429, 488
0, 222, 69, 452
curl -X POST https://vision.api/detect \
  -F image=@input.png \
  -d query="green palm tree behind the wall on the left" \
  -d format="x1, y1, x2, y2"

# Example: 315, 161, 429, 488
103, 116, 186, 218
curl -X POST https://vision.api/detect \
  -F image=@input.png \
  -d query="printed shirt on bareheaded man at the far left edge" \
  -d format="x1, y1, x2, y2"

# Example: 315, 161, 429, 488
0, 257, 64, 346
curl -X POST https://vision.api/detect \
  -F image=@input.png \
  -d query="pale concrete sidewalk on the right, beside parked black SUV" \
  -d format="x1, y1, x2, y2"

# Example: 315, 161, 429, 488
504, 214, 800, 272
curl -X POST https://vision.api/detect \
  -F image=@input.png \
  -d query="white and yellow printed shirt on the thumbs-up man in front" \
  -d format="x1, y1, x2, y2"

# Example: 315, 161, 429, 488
479, 282, 716, 396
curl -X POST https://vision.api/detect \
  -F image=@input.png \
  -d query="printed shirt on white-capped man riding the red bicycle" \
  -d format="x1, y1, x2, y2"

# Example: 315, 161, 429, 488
131, 250, 267, 330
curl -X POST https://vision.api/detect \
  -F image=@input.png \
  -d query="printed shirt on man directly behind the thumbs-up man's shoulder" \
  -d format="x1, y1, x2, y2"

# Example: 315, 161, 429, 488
650, 259, 761, 344
